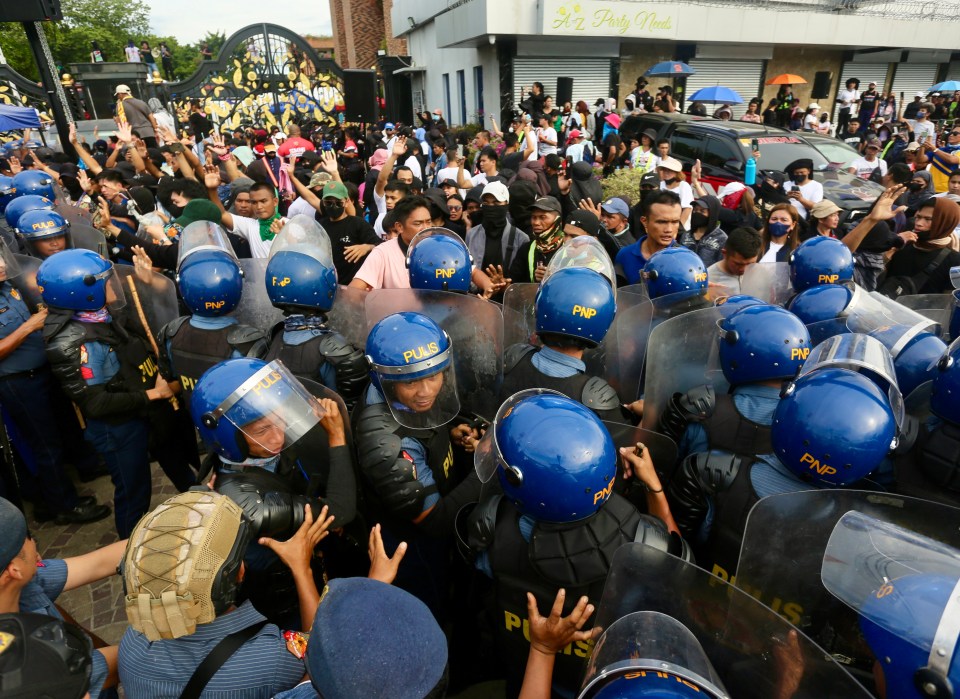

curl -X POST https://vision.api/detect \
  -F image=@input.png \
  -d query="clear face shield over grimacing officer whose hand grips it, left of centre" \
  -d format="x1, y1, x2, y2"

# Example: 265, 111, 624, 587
201, 361, 323, 458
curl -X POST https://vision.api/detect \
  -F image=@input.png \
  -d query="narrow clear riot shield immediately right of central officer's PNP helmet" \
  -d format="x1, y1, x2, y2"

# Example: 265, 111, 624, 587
608, 288, 653, 403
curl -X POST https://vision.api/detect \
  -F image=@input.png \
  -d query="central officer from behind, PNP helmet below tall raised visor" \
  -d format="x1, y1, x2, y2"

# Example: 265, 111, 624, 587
501, 267, 629, 421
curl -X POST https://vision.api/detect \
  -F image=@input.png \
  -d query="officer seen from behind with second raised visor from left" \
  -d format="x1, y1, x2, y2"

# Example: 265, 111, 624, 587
265, 216, 368, 409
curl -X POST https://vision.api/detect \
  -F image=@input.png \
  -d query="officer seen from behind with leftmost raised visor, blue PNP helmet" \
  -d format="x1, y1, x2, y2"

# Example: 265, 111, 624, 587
159, 221, 266, 405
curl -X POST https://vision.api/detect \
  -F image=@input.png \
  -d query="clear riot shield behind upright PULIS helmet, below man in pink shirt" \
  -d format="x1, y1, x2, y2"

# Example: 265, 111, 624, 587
364, 289, 504, 419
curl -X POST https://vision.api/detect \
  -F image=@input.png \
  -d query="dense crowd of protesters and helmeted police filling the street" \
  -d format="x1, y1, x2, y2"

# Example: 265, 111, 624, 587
0, 74, 960, 699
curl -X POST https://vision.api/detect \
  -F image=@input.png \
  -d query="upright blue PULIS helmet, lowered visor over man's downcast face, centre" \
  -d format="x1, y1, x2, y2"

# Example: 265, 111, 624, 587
366, 312, 460, 429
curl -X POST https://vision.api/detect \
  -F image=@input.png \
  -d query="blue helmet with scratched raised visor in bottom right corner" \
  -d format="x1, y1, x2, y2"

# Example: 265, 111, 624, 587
820, 510, 960, 699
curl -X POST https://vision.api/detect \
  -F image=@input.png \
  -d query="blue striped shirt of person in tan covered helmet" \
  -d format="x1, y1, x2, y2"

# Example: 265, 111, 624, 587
119, 601, 305, 699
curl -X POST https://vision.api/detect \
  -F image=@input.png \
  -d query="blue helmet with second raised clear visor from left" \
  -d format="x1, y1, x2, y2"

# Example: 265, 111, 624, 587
266, 216, 337, 313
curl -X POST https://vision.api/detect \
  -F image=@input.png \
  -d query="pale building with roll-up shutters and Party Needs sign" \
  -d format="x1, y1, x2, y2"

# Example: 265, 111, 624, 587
388, 0, 960, 125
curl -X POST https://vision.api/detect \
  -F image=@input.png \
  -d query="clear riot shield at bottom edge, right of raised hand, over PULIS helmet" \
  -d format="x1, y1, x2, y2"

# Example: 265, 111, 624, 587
580, 544, 870, 699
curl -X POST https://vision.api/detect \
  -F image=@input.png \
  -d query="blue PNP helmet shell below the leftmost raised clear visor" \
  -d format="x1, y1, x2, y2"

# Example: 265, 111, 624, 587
177, 250, 243, 318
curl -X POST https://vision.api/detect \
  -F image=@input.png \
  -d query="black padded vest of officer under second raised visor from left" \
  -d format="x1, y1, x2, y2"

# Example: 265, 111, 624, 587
264, 323, 370, 410
